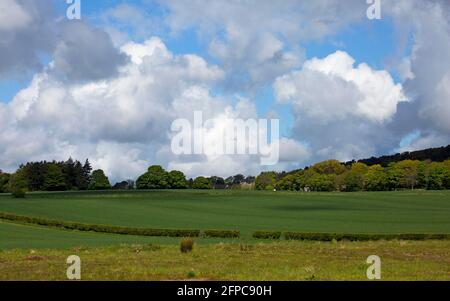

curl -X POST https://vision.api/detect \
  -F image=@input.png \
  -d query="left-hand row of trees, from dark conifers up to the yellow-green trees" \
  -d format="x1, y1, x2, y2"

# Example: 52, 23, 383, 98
0, 159, 255, 193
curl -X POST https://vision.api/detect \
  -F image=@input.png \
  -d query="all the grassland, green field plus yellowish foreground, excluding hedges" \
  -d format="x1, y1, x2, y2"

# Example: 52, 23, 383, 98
0, 191, 450, 280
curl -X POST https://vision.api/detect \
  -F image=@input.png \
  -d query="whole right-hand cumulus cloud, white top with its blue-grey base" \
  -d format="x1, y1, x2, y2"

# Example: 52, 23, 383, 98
275, 51, 406, 160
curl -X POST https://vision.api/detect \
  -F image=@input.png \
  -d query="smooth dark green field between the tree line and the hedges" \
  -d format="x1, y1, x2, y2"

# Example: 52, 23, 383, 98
0, 190, 450, 234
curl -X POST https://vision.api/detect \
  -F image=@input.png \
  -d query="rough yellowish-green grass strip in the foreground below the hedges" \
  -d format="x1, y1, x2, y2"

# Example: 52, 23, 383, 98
0, 241, 450, 280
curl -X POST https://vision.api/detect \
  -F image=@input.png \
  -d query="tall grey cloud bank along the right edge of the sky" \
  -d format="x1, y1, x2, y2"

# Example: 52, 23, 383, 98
388, 0, 450, 149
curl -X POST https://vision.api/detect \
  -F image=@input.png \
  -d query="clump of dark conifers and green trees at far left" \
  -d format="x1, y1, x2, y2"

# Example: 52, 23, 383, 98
0, 158, 111, 192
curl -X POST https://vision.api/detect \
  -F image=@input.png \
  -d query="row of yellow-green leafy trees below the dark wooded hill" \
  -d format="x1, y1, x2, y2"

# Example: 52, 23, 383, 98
255, 160, 450, 191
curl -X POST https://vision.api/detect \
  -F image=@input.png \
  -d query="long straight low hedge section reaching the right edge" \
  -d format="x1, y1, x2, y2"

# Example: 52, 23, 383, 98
284, 232, 450, 241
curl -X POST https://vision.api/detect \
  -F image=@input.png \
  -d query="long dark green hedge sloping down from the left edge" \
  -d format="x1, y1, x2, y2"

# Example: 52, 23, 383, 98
0, 212, 200, 237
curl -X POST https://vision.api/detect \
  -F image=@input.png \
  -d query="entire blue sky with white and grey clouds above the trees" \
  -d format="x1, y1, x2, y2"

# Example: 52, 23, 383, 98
0, 0, 450, 181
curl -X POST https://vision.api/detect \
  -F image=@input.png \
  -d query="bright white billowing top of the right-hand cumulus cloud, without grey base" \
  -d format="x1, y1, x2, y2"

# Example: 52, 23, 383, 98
275, 51, 405, 122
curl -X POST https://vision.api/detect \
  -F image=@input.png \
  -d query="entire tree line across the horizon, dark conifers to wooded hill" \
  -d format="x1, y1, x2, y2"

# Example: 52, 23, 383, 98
0, 148, 450, 193
